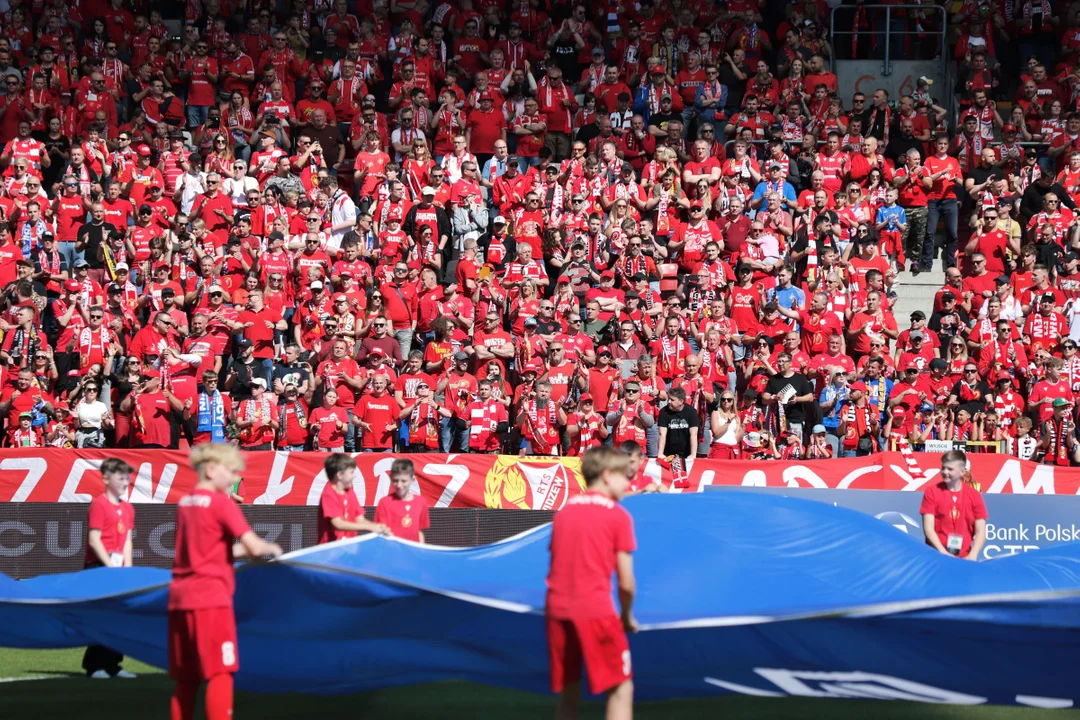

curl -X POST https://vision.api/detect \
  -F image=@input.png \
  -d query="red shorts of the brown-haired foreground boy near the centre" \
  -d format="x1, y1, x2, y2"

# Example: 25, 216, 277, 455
548, 615, 633, 695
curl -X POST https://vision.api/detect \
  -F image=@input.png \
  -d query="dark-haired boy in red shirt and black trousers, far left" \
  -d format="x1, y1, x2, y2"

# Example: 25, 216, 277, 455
82, 458, 135, 680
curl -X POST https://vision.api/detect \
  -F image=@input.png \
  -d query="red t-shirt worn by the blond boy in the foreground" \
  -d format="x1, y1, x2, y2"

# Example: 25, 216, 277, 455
166, 487, 252, 610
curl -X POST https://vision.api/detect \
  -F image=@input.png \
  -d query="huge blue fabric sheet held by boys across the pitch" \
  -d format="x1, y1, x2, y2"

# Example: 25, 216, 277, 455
0, 492, 1080, 707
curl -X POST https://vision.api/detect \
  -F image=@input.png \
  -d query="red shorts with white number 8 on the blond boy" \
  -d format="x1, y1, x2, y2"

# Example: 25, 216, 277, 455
168, 608, 240, 682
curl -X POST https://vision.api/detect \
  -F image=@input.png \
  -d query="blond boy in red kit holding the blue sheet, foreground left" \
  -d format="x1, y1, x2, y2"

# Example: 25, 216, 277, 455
168, 443, 281, 720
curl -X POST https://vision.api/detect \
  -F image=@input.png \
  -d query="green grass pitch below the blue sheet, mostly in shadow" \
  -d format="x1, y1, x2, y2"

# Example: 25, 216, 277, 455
0, 649, 1080, 720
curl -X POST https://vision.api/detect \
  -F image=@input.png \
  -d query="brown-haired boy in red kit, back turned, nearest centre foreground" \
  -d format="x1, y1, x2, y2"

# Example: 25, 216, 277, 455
545, 447, 637, 720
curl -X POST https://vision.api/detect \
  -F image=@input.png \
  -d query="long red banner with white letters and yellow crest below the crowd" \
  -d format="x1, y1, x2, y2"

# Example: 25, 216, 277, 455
0, 448, 1080, 511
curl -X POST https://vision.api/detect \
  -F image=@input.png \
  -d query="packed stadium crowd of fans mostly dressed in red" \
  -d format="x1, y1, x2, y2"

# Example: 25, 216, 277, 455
0, 0, 1080, 466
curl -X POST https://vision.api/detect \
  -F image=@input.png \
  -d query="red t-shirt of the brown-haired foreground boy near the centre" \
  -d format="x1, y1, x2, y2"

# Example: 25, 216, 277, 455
546, 492, 637, 620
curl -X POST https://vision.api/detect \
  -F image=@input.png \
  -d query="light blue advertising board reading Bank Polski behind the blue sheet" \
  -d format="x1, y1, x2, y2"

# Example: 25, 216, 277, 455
706, 485, 1080, 560
